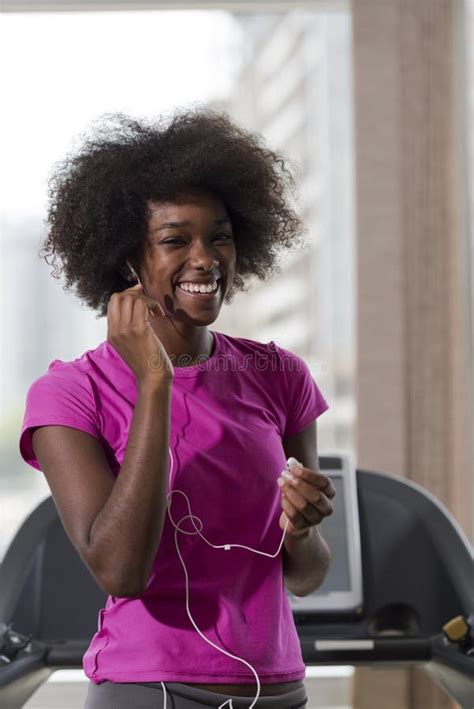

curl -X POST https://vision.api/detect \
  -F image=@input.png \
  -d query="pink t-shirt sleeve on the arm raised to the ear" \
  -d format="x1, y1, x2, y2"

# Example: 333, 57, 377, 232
19, 360, 101, 471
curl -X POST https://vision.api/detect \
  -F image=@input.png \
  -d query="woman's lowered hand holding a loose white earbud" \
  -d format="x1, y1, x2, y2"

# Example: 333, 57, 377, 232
278, 465, 336, 538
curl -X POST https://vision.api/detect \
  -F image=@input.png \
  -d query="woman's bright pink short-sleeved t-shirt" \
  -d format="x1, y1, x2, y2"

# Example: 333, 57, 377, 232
20, 331, 329, 684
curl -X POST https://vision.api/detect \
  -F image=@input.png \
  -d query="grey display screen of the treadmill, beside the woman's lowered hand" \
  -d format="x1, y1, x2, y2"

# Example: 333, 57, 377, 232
313, 471, 352, 596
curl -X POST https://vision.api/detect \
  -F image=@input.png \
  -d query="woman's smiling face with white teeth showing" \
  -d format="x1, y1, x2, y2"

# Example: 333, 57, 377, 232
139, 192, 236, 326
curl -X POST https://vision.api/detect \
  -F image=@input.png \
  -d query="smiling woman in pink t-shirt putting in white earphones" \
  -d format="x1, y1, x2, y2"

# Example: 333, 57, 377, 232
20, 108, 334, 709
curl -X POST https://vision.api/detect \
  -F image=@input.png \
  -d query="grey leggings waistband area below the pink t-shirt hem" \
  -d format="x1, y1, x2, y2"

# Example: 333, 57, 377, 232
84, 680, 308, 709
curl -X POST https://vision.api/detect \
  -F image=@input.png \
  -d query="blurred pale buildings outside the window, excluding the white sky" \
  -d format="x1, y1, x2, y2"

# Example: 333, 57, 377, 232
0, 6, 355, 559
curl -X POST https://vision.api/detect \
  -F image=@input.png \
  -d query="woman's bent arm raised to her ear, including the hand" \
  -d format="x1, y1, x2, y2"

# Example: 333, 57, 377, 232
32, 287, 173, 597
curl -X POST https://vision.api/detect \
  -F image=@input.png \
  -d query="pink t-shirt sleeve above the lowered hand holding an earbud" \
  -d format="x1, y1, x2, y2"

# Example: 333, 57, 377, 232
270, 341, 329, 438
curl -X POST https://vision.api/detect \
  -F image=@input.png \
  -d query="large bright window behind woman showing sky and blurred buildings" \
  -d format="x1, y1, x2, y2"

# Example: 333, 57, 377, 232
0, 8, 355, 559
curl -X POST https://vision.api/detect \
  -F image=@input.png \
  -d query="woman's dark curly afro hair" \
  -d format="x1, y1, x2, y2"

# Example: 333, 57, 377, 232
39, 106, 306, 318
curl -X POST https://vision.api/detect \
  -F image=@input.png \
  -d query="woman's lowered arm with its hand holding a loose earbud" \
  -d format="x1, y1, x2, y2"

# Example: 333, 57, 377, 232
280, 421, 335, 596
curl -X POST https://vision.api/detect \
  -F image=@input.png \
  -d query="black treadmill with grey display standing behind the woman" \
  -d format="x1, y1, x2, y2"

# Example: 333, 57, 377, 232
0, 453, 474, 709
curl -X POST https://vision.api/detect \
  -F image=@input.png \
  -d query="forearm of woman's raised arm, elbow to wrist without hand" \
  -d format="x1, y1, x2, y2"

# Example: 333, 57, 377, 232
87, 381, 172, 596
